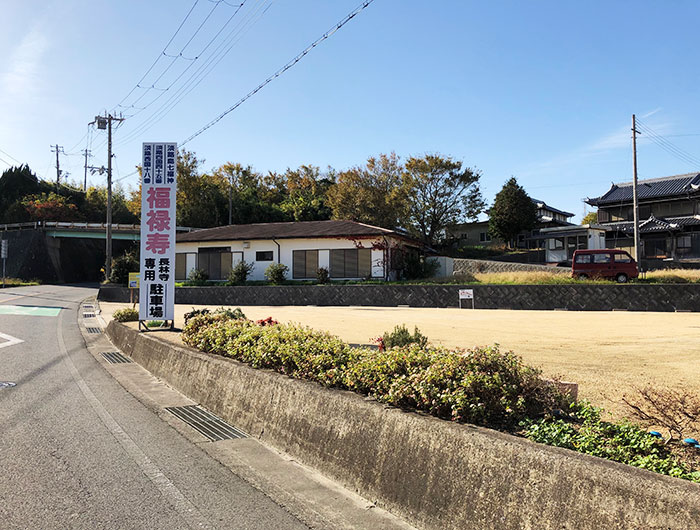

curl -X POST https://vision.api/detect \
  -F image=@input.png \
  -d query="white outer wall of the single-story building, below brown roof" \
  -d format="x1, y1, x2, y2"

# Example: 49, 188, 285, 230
175, 237, 401, 280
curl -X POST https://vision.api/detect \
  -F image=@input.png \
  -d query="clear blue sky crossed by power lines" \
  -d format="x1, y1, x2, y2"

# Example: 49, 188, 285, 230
0, 0, 700, 219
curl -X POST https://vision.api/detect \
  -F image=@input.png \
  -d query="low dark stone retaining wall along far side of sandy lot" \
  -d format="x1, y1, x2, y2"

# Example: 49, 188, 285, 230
99, 284, 700, 311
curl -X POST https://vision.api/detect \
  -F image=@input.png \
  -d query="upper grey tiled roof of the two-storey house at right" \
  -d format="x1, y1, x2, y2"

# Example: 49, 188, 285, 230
586, 173, 700, 206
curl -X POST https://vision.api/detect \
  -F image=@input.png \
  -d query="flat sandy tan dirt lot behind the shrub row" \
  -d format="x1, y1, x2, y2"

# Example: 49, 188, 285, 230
100, 302, 700, 416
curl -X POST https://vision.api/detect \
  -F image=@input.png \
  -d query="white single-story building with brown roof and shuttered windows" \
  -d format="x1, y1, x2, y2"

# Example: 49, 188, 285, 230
175, 221, 423, 280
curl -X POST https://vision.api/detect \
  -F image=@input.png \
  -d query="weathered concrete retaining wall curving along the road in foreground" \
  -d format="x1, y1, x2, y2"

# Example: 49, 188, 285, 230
107, 322, 700, 530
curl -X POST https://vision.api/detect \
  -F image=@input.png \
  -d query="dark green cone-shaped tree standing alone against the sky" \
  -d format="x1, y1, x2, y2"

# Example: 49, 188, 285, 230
489, 177, 537, 248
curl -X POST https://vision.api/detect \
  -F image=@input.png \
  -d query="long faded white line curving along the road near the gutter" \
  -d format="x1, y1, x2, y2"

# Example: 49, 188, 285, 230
56, 311, 211, 529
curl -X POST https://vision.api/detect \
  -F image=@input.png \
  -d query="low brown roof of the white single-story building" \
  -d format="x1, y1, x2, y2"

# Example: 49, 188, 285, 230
177, 221, 411, 243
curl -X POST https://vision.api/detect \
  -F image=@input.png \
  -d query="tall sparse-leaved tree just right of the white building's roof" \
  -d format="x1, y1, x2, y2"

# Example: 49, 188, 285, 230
403, 154, 485, 245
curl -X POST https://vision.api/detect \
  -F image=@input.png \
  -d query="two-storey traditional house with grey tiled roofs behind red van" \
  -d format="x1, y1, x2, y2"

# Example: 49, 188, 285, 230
586, 173, 700, 262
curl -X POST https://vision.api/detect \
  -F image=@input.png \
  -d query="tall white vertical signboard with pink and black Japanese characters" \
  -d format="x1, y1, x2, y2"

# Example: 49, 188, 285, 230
139, 143, 177, 321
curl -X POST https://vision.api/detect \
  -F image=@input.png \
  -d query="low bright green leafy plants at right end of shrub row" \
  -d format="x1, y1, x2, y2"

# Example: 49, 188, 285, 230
521, 401, 700, 482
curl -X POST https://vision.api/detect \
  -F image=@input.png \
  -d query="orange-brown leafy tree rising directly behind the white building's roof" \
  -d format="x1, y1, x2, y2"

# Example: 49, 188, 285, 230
328, 152, 408, 229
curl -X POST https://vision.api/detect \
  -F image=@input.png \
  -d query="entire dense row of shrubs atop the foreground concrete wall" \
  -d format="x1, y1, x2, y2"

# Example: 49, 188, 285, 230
182, 312, 700, 482
